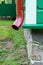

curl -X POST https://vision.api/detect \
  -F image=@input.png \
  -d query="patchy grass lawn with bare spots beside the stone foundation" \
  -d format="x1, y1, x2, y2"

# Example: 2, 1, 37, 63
0, 20, 27, 65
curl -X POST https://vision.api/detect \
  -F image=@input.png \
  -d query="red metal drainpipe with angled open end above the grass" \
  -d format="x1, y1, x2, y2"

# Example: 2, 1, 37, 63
12, 0, 24, 30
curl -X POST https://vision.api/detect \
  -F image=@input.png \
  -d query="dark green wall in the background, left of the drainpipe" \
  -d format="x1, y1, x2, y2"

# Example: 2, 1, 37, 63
0, 0, 16, 17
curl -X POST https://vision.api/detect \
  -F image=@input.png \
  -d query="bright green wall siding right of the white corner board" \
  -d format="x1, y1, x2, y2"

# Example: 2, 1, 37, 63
36, 0, 43, 24
